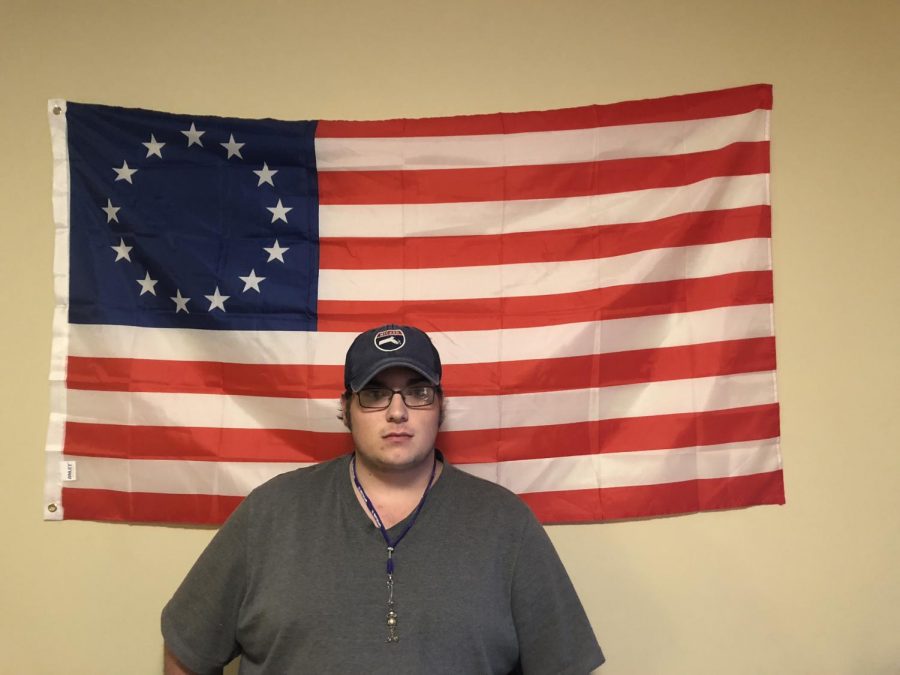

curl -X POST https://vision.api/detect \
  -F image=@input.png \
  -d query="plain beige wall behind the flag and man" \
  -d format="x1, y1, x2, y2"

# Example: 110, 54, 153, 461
0, 0, 900, 675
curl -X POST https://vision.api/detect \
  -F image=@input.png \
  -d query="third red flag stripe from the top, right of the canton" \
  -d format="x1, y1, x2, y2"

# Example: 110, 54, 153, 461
319, 206, 771, 270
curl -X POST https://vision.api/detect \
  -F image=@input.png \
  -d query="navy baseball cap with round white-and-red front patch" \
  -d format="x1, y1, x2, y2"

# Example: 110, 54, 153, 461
344, 324, 441, 391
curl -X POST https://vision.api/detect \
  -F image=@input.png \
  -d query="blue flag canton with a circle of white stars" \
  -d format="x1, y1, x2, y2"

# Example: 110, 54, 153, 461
66, 103, 319, 330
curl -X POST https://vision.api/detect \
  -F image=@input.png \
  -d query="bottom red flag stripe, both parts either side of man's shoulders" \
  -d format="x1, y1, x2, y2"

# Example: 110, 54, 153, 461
62, 470, 784, 525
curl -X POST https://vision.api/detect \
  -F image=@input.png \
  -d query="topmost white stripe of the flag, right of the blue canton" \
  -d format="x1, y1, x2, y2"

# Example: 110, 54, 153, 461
316, 110, 769, 171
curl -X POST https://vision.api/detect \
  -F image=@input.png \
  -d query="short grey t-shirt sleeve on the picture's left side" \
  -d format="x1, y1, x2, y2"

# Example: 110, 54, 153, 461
162, 500, 250, 673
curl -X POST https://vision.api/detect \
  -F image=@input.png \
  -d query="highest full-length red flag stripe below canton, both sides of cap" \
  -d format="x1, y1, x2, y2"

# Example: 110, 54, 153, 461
67, 337, 775, 398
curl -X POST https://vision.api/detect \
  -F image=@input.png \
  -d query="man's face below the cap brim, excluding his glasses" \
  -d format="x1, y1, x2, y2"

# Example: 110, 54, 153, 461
348, 366, 441, 471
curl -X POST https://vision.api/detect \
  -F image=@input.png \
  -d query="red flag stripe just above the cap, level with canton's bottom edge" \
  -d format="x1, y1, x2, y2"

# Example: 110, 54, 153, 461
318, 270, 772, 332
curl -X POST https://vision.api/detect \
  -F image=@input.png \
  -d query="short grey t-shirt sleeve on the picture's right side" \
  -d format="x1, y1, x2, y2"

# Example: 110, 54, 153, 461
512, 518, 605, 675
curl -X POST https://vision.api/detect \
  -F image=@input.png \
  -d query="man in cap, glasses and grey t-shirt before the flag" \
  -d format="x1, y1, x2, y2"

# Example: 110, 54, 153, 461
162, 325, 603, 674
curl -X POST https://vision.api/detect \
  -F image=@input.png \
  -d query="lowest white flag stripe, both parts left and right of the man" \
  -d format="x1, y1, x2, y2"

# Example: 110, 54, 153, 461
66, 439, 781, 497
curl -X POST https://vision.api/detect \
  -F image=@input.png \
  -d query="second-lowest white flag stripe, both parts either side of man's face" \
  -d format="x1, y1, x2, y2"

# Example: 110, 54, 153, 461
68, 371, 775, 433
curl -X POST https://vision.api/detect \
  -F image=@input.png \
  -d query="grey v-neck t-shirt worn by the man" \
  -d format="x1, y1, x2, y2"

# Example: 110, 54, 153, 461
162, 457, 603, 674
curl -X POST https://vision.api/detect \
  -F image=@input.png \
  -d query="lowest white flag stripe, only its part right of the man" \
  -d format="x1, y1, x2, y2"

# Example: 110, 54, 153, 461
459, 438, 781, 494
